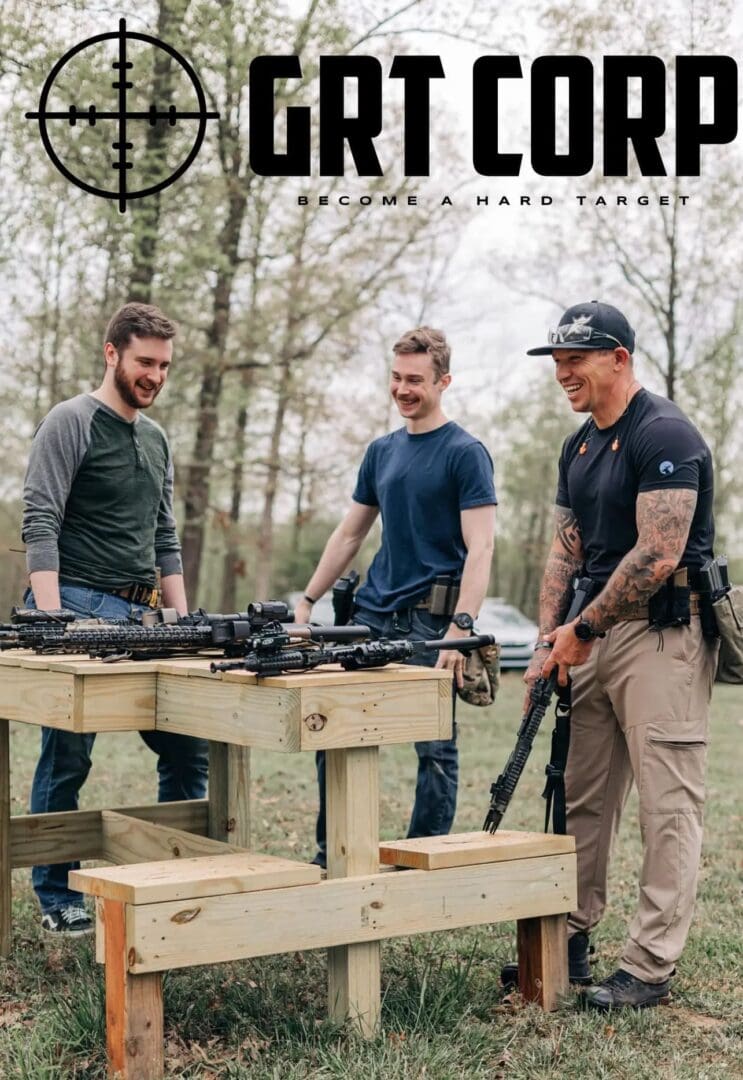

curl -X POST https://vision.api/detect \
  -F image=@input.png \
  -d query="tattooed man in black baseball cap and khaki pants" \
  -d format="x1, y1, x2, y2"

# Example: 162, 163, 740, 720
525, 300, 717, 1009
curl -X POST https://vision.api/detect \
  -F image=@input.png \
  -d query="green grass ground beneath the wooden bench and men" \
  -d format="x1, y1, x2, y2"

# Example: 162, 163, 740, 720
0, 674, 743, 1080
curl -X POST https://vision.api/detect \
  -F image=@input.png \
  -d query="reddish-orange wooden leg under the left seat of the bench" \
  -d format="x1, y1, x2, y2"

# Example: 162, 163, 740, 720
104, 900, 164, 1080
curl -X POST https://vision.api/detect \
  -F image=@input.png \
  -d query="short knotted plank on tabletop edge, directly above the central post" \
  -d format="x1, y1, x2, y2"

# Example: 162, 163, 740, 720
300, 669, 451, 751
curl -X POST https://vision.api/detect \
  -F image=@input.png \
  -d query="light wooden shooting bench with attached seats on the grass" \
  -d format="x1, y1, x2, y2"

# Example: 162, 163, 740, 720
0, 652, 577, 1080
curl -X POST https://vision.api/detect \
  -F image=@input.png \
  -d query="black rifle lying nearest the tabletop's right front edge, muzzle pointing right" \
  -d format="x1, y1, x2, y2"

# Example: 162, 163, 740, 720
211, 626, 495, 675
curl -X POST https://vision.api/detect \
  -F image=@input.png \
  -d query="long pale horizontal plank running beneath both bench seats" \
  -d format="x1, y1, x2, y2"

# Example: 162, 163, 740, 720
130, 854, 577, 971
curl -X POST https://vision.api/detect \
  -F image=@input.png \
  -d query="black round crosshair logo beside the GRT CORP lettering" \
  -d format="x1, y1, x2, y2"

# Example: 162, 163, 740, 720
26, 18, 219, 214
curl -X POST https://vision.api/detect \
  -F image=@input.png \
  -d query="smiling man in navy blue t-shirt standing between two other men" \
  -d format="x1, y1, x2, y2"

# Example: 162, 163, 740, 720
296, 326, 497, 866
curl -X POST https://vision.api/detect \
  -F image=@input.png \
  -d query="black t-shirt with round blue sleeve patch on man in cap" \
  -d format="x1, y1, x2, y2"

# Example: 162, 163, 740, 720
556, 390, 715, 581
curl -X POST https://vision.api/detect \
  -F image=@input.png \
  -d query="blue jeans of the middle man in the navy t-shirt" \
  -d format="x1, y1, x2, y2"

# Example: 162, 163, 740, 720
314, 607, 459, 866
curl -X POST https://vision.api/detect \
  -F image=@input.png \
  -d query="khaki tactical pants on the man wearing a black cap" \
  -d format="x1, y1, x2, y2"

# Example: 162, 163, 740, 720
566, 617, 717, 983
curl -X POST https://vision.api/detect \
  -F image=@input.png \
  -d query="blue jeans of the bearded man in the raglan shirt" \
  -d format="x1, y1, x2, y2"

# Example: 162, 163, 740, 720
24, 584, 208, 912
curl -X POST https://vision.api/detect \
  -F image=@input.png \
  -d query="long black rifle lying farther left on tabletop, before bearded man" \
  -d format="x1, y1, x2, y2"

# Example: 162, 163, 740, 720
0, 600, 369, 661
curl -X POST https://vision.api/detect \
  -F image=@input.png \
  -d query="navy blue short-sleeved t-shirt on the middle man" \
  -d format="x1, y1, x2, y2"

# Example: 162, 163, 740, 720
353, 420, 498, 612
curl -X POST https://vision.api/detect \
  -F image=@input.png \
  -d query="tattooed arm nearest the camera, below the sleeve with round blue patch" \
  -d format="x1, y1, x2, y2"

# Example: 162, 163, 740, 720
584, 488, 697, 632
